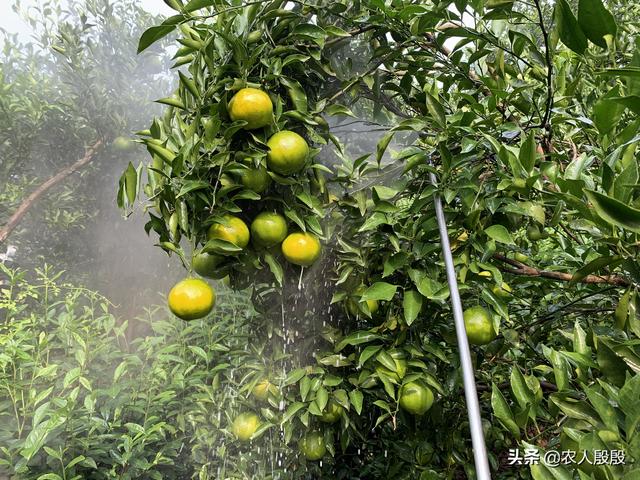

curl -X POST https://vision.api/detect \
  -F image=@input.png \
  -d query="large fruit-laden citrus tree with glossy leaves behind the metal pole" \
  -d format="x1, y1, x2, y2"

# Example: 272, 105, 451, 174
126, 0, 640, 479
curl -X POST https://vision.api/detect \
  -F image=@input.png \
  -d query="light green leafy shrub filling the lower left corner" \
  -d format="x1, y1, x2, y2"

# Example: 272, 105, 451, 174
0, 265, 250, 480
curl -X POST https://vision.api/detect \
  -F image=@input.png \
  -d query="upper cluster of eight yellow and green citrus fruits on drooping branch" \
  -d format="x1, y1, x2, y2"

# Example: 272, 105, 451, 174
168, 88, 322, 320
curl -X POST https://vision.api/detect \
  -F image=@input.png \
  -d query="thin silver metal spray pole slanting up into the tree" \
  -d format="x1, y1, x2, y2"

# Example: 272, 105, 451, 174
430, 173, 491, 480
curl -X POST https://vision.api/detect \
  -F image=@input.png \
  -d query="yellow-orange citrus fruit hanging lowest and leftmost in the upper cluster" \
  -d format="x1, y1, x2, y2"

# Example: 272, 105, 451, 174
168, 278, 216, 320
